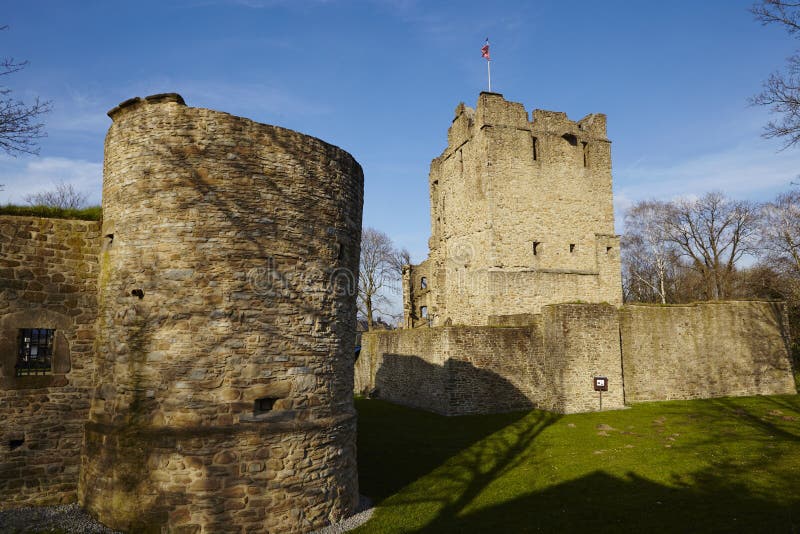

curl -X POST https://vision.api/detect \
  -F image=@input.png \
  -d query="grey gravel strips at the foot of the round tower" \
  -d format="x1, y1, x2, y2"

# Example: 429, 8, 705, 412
0, 495, 375, 534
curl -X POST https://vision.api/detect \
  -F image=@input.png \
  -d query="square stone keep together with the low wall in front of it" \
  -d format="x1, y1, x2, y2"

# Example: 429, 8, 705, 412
355, 93, 796, 415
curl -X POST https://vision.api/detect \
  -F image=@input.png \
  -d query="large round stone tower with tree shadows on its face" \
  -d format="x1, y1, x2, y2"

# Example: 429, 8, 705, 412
79, 94, 363, 533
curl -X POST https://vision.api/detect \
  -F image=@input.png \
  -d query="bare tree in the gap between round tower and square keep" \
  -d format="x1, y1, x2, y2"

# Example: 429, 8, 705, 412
358, 228, 400, 330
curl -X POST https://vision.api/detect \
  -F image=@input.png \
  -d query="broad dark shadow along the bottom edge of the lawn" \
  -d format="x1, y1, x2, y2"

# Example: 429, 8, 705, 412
416, 471, 800, 533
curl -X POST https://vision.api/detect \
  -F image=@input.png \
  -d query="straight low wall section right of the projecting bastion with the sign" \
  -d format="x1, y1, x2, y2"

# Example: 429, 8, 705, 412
621, 301, 796, 402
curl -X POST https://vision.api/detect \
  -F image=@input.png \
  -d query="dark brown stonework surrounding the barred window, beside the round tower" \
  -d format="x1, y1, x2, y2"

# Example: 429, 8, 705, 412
0, 216, 100, 509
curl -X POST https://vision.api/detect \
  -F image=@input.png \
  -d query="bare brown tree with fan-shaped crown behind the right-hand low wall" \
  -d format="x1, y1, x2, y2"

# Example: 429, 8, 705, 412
665, 192, 758, 300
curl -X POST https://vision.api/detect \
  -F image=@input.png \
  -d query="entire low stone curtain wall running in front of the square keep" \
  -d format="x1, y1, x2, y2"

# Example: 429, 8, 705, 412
356, 301, 796, 415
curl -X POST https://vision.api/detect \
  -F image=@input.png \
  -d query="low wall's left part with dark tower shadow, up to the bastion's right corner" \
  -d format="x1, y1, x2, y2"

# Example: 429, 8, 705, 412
355, 304, 624, 415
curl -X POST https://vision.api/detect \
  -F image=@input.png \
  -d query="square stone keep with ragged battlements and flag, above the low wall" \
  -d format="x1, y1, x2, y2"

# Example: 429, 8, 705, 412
403, 92, 622, 327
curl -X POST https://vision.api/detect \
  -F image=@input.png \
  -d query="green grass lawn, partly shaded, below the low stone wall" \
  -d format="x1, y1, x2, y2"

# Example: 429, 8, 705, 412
356, 396, 800, 533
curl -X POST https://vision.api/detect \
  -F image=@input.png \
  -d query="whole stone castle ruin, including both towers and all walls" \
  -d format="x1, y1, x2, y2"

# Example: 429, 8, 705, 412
0, 93, 795, 533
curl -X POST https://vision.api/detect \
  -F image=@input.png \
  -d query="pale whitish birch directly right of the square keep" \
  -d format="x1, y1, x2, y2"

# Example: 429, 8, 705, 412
622, 200, 677, 304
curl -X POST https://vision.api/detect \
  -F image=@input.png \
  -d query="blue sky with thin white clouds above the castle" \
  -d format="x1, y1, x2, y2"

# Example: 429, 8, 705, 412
0, 0, 800, 261
